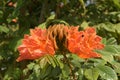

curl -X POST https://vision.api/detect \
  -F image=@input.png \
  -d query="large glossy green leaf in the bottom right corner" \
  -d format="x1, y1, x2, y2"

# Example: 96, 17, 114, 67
97, 66, 118, 80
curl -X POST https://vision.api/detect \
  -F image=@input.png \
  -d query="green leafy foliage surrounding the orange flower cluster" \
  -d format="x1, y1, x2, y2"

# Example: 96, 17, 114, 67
0, 0, 120, 80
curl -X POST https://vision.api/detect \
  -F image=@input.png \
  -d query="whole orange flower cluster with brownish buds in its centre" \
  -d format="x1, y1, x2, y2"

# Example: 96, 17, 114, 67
17, 24, 104, 62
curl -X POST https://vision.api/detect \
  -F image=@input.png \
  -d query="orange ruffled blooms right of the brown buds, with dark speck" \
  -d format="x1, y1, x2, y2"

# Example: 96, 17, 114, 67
67, 27, 104, 58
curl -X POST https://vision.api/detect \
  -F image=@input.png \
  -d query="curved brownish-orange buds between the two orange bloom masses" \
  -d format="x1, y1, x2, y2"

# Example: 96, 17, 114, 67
47, 24, 68, 49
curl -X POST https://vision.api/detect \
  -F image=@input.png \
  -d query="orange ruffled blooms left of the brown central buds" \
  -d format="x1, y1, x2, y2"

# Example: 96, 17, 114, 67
17, 28, 55, 62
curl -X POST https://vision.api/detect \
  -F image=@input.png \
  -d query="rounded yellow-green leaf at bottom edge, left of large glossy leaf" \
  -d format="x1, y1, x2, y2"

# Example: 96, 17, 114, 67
85, 68, 99, 80
